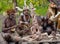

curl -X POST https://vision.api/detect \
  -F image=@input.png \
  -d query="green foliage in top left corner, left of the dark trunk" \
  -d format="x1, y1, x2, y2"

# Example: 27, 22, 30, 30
0, 0, 13, 13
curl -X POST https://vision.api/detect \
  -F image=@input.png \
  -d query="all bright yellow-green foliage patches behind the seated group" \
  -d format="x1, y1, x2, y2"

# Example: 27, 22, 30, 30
0, 0, 49, 15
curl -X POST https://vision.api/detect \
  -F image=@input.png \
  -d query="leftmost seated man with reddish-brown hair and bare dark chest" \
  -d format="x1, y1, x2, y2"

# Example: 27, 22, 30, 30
2, 9, 20, 43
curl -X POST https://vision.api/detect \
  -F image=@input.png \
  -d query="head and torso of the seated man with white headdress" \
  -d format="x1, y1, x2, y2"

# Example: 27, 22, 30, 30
19, 8, 31, 24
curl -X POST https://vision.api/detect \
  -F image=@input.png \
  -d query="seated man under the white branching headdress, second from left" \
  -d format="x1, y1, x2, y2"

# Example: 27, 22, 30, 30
17, 7, 31, 36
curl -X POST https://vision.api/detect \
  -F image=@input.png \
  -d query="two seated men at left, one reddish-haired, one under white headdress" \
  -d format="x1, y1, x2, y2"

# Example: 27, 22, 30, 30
2, 4, 31, 44
